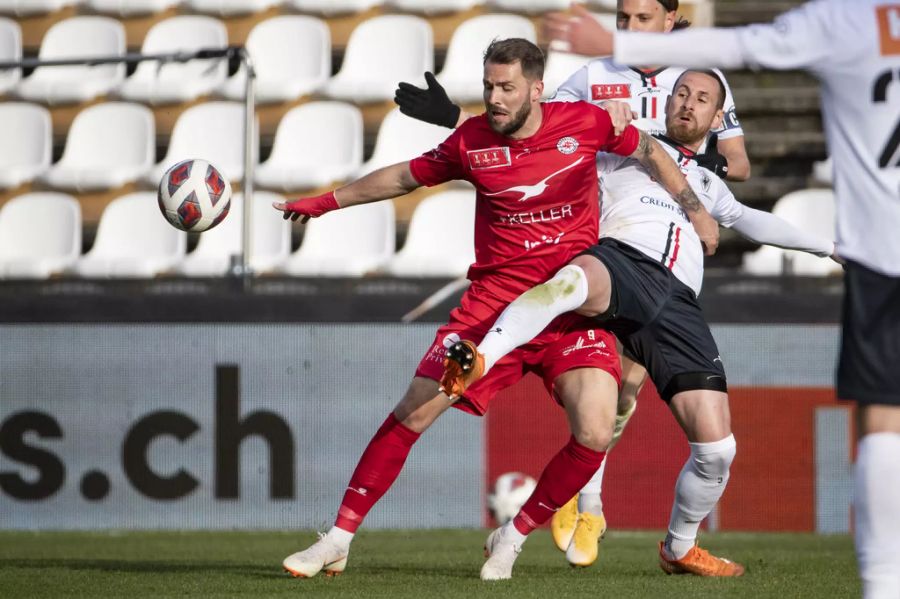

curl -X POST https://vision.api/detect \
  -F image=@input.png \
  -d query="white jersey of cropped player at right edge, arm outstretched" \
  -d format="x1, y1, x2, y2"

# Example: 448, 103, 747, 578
615, 0, 900, 276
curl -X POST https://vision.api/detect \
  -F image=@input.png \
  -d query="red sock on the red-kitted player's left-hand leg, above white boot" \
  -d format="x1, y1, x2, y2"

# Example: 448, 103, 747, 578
334, 412, 424, 532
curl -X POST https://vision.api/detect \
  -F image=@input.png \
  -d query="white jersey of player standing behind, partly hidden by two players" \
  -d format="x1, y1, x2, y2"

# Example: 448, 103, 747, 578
550, 58, 744, 139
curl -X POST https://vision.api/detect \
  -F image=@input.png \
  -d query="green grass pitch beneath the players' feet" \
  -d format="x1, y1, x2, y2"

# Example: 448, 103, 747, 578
0, 530, 861, 599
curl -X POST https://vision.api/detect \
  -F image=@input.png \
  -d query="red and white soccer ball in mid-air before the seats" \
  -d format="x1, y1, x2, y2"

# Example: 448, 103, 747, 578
157, 158, 231, 232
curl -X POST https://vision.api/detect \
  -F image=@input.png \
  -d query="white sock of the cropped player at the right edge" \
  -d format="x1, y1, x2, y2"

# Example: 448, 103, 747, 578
854, 433, 900, 599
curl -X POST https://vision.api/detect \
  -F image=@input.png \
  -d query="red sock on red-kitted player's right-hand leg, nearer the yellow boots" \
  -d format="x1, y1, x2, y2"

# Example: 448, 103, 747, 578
513, 437, 606, 535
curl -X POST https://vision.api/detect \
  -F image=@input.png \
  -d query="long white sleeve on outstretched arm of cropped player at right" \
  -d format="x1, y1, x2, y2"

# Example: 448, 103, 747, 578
614, 0, 841, 70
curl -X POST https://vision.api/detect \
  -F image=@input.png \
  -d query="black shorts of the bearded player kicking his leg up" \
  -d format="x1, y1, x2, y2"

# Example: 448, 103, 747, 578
582, 238, 728, 402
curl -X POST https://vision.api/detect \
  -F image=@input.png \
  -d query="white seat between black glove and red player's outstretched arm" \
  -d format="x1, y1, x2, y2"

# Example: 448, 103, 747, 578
356, 108, 451, 177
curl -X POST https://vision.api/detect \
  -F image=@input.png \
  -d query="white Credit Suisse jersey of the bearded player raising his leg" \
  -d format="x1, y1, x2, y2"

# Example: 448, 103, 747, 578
597, 143, 744, 295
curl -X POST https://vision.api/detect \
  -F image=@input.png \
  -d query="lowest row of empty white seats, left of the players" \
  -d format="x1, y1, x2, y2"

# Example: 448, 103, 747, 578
0, 190, 475, 279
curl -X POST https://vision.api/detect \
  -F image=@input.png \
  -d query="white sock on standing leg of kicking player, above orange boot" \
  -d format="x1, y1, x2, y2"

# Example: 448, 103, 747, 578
665, 435, 737, 559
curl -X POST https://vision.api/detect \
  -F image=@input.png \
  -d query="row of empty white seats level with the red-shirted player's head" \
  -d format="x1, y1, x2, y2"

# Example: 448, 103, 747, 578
0, 14, 592, 105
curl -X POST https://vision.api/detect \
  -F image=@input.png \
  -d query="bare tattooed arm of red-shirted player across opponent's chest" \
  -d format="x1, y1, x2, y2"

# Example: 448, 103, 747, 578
631, 131, 719, 256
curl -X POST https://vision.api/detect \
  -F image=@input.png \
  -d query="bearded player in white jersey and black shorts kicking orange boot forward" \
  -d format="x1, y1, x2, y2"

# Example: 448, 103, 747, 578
442, 71, 834, 576
